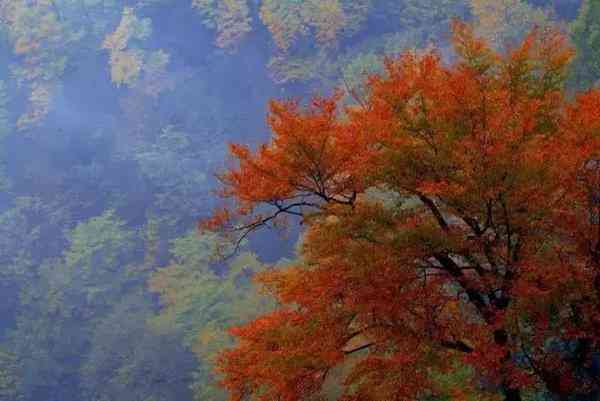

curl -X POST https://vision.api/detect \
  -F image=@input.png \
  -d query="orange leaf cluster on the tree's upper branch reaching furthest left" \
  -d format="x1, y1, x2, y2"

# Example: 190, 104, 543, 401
203, 90, 364, 234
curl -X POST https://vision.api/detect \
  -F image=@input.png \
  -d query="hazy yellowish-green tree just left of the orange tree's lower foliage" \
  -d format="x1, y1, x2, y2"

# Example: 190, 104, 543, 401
150, 233, 271, 400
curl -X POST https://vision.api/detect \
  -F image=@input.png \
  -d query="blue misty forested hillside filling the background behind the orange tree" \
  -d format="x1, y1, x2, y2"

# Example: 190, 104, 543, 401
0, 0, 584, 401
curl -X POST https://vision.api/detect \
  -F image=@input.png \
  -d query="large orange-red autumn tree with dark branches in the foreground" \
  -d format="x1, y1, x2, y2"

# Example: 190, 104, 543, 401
201, 23, 600, 401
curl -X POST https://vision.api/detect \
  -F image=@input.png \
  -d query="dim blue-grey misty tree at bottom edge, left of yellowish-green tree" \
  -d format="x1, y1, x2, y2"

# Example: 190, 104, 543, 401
81, 288, 194, 401
